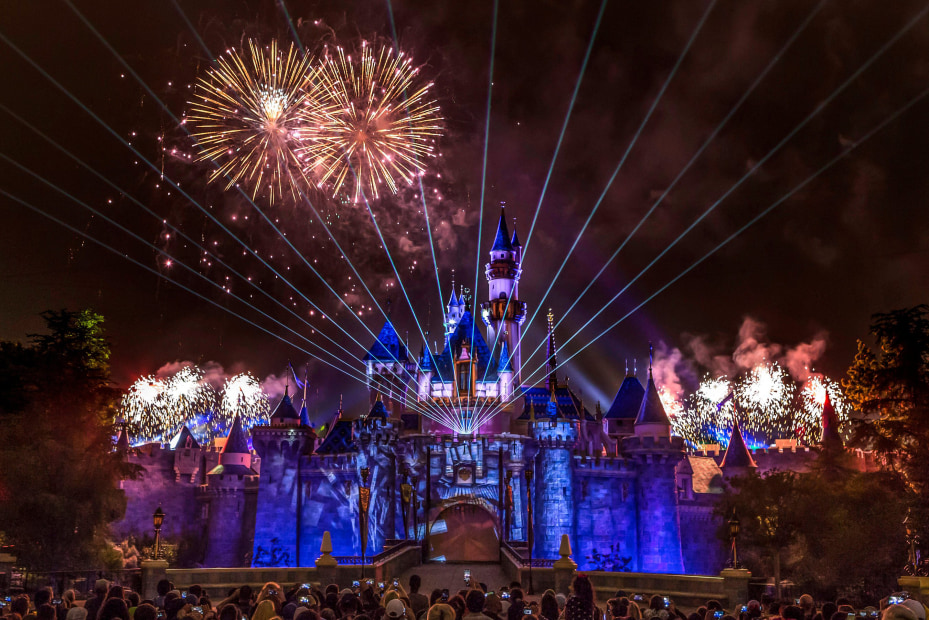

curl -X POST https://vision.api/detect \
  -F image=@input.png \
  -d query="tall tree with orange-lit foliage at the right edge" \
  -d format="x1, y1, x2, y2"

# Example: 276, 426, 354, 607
842, 305, 929, 538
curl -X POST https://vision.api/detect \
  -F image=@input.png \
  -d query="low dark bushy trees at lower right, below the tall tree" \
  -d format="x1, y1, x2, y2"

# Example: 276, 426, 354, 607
717, 469, 906, 602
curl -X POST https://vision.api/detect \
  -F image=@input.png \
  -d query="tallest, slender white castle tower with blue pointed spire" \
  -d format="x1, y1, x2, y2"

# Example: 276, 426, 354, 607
481, 209, 526, 385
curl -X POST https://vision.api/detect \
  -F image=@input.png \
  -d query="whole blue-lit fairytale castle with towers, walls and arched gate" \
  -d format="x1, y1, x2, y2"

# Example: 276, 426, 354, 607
113, 213, 864, 574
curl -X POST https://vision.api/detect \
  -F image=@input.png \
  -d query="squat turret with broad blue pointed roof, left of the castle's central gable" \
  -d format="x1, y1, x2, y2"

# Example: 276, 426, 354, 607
362, 318, 416, 418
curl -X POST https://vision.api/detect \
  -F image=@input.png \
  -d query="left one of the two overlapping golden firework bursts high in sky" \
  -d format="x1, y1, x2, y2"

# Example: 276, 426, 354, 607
186, 40, 321, 203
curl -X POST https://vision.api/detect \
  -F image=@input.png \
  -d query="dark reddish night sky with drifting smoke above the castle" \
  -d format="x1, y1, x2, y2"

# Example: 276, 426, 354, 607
0, 0, 929, 418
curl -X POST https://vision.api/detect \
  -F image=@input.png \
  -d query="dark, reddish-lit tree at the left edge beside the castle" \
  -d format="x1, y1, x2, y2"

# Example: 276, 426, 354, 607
0, 310, 132, 570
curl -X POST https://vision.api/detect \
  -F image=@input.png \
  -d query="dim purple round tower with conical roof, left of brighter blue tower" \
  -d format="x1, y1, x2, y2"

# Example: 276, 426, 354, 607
203, 416, 258, 567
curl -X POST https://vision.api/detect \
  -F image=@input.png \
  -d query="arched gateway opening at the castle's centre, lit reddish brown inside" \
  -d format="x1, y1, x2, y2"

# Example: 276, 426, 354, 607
428, 502, 500, 562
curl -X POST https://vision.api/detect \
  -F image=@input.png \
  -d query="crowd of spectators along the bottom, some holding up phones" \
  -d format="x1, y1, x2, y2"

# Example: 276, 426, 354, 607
0, 574, 926, 620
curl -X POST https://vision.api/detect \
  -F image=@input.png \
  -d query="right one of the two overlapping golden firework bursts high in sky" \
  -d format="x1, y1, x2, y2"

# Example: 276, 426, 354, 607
298, 41, 441, 203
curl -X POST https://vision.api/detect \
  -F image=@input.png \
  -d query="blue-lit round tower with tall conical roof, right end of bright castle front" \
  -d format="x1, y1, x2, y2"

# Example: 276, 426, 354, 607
622, 356, 684, 573
